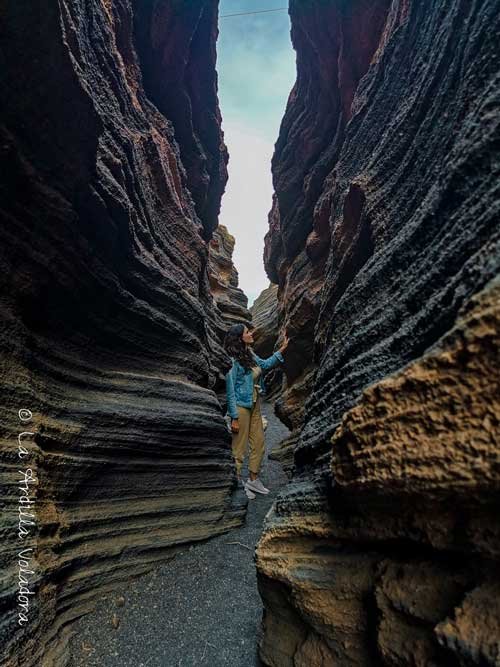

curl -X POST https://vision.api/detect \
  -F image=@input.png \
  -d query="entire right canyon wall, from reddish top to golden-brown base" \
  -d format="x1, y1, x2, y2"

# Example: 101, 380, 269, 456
257, 0, 500, 667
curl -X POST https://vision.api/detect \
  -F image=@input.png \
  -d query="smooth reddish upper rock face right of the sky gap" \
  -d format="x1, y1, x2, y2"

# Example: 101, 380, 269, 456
266, 0, 390, 285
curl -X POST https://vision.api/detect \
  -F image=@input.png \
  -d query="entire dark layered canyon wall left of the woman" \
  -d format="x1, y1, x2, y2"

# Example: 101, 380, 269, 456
0, 0, 242, 667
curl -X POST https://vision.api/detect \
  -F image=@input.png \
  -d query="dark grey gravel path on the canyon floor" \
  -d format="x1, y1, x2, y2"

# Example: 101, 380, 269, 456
71, 403, 288, 667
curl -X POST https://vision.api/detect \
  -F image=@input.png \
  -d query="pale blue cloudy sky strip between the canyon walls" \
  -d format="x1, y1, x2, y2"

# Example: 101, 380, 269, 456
217, 0, 296, 306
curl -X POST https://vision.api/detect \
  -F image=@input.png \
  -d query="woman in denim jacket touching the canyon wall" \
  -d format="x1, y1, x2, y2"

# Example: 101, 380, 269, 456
224, 324, 288, 498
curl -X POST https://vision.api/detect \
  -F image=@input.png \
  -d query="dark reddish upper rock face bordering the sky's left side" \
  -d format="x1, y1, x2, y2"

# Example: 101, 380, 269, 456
134, 0, 228, 239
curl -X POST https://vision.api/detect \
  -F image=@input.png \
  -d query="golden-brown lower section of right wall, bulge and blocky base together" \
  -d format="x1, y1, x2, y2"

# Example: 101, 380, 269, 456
257, 280, 500, 667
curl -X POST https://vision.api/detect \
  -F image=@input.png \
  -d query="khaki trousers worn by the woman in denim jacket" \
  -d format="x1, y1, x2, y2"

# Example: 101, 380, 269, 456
232, 398, 265, 476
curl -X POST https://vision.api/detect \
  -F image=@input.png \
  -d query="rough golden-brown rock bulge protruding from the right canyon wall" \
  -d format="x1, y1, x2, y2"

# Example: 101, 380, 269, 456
332, 281, 500, 506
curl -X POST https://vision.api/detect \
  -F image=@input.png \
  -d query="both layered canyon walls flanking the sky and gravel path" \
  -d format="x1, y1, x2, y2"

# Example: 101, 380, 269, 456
0, 0, 500, 667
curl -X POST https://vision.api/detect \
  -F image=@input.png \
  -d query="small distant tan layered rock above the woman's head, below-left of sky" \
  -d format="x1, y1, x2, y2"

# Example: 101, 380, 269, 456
208, 225, 252, 329
